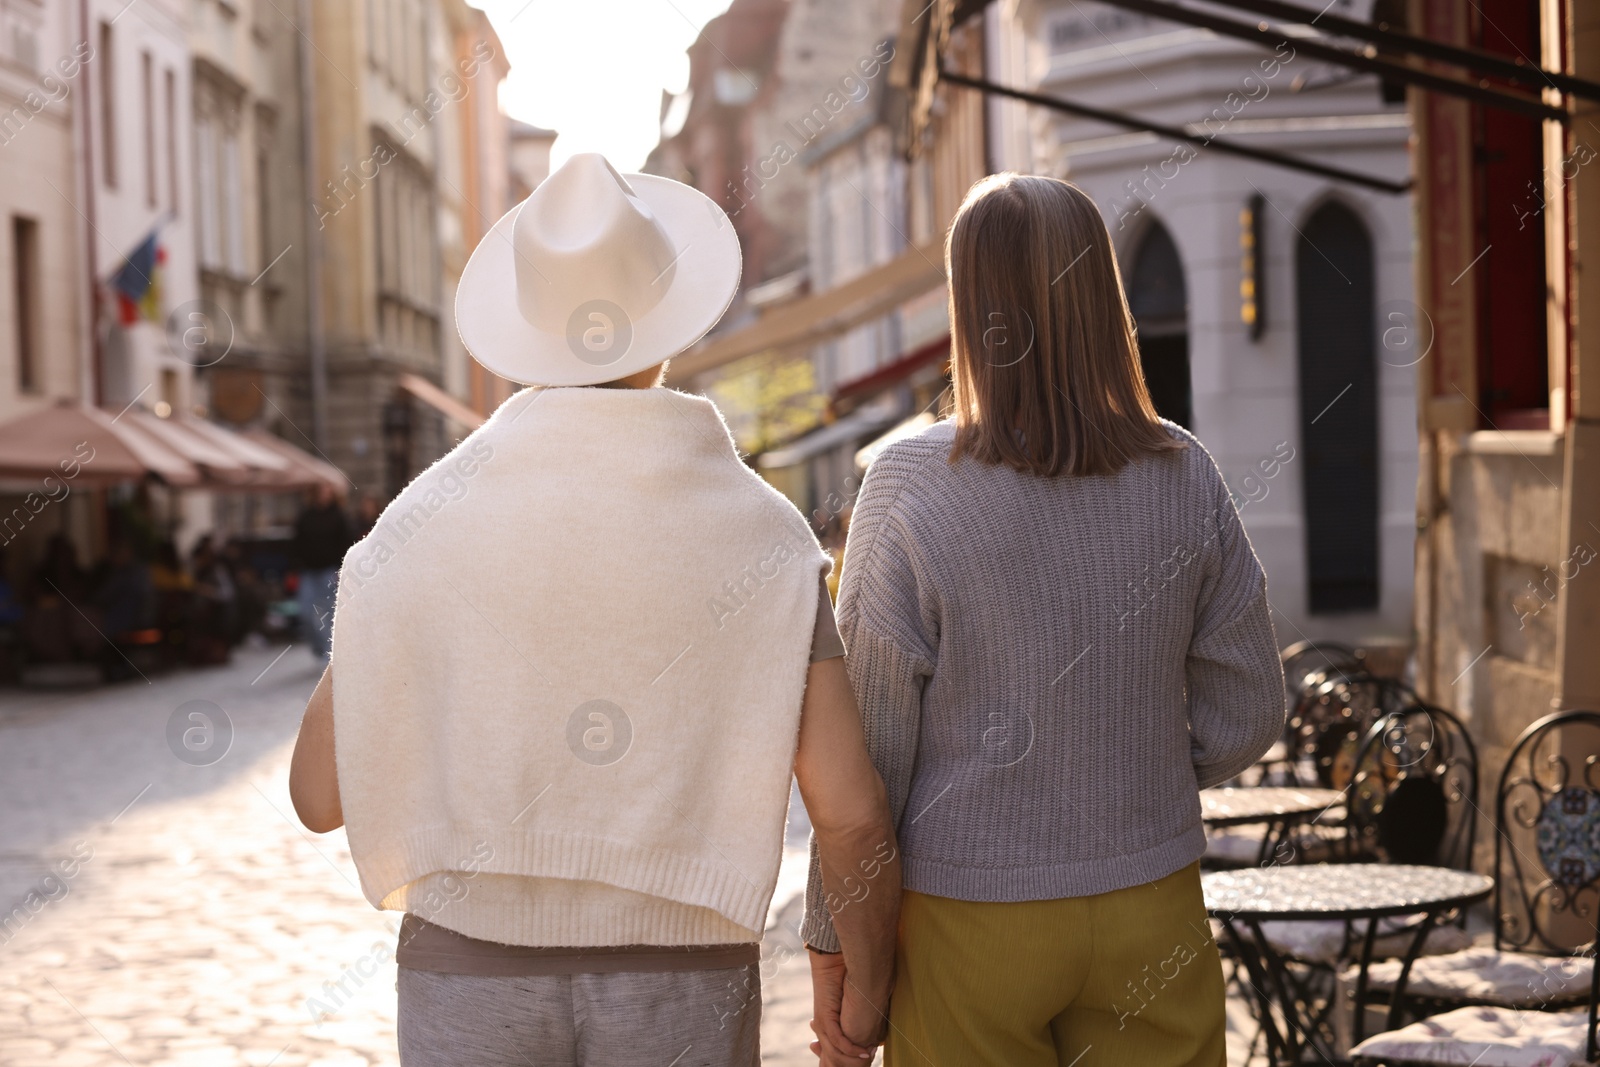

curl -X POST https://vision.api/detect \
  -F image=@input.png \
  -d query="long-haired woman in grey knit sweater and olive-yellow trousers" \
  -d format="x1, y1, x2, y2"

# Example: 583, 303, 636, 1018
805, 174, 1285, 1067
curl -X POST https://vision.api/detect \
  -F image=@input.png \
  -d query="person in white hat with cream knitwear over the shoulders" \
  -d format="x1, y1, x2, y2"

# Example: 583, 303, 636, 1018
290, 155, 901, 1067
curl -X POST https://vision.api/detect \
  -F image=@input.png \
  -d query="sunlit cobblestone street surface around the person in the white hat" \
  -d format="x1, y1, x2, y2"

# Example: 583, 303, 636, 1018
0, 646, 816, 1067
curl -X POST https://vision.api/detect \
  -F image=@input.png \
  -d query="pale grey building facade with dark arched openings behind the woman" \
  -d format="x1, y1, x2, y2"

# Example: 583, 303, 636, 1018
1004, 0, 1418, 645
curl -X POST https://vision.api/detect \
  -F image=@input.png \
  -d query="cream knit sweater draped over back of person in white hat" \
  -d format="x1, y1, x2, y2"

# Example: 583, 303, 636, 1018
324, 389, 827, 947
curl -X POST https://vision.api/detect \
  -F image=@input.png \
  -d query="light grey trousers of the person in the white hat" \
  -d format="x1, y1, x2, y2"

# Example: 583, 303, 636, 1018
398, 965, 762, 1067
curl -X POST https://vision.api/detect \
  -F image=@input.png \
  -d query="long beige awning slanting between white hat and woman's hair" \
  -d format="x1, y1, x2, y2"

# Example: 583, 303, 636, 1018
670, 242, 944, 381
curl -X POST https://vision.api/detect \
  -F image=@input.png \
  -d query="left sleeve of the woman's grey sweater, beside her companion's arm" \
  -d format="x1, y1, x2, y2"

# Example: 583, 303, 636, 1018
800, 453, 938, 952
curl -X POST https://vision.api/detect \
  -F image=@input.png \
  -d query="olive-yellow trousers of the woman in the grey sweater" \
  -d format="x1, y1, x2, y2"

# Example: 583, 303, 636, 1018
883, 862, 1226, 1067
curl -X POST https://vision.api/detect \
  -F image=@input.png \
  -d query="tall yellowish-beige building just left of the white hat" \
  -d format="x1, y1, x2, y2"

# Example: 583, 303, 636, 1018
301, 0, 504, 499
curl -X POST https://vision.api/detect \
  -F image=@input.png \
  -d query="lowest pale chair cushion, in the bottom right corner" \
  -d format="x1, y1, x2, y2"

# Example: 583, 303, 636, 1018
1350, 1008, 1589, 1067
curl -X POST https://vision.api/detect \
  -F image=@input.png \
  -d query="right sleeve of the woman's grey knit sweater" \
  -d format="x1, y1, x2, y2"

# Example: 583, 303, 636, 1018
1186, 464, 1286, 789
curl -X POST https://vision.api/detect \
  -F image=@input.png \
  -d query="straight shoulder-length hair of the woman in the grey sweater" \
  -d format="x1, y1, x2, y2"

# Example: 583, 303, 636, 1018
944, 174, 1184, 477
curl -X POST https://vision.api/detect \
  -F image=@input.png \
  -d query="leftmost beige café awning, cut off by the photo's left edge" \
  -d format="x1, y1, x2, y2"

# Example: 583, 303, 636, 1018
0, 402, 202, 485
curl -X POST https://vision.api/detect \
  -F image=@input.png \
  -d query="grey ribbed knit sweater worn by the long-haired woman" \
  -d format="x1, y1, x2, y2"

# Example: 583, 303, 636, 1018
802, 422, 1285, 950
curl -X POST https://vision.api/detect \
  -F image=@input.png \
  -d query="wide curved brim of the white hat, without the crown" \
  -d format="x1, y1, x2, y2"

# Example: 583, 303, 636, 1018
456, 174, 744, 386
